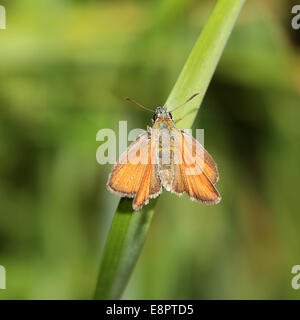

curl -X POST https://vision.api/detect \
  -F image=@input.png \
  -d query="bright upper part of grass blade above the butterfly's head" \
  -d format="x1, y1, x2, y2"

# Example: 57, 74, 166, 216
166, 0, 245, 128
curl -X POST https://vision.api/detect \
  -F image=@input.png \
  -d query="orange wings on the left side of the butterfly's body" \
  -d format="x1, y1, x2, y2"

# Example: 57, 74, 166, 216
107, 131, 161, 210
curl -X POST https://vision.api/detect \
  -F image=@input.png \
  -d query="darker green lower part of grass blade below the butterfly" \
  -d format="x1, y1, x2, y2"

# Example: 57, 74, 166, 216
95, 198, 157, 299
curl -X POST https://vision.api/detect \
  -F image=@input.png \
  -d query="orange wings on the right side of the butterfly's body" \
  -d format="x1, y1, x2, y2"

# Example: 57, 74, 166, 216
171, 129, 221, 204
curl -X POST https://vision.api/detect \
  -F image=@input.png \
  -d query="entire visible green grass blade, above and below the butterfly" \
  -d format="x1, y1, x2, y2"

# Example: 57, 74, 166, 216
95, 0, 245, 299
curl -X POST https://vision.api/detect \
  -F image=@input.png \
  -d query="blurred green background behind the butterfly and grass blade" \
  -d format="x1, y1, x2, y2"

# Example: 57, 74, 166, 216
0, 0, 300, 299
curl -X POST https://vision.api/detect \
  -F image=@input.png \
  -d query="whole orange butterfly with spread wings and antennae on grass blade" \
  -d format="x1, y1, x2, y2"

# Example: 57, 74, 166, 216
107, 94, 221, 210
